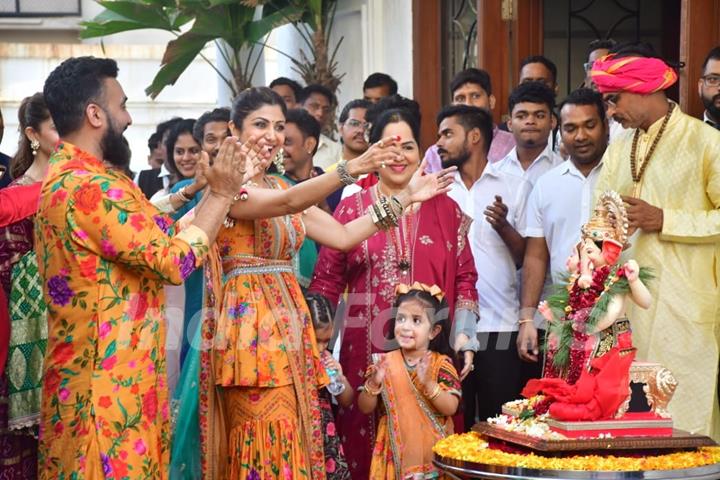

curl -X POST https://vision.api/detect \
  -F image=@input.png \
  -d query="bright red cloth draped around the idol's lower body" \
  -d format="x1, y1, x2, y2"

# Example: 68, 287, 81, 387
522, 347, 635, 421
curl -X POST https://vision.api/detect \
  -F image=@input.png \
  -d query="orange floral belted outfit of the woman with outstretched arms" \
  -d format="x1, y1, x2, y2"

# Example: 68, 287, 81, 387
199, 177, 328, 480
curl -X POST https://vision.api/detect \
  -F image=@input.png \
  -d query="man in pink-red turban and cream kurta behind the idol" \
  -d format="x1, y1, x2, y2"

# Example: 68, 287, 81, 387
593, 50, 720, 440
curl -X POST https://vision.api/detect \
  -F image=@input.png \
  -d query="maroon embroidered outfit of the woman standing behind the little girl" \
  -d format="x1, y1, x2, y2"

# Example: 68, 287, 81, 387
310, 187, 477, 478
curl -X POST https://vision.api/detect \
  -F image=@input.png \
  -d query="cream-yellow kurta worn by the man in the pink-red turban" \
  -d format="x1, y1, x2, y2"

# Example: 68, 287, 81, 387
595, 106, 720, 440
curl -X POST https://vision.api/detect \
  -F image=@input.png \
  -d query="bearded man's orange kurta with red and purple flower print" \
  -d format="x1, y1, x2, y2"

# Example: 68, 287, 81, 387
35, 143, 208, 480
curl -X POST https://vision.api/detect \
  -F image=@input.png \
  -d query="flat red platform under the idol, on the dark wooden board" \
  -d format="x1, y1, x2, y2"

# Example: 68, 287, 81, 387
547, 412, 673, 438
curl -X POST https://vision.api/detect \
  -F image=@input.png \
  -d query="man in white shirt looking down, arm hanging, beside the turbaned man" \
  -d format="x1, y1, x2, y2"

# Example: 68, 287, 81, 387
517, 88, 608, 371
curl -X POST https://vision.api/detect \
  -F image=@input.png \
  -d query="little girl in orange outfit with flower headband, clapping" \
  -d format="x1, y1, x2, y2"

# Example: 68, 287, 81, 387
358, 282, 460, 480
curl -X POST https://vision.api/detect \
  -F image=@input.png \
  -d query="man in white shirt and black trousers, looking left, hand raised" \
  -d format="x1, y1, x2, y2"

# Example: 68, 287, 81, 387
437, 105, 530, 428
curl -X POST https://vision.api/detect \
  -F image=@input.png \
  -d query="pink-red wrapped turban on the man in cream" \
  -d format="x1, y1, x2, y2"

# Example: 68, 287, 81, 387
590, 54, 677, 94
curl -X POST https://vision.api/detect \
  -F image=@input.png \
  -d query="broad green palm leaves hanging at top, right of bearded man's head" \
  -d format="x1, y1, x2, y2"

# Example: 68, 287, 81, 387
80, 0, 306, 98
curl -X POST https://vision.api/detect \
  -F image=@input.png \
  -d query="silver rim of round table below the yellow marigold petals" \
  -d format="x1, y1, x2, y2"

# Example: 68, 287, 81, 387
433, 454, 720, 480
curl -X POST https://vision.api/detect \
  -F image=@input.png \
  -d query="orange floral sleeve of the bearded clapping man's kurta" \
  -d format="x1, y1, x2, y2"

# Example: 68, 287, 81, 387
65, 173, 208, 285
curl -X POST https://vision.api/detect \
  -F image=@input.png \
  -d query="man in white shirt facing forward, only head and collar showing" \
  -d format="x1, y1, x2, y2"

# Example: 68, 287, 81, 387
498, 82, 563, 185
